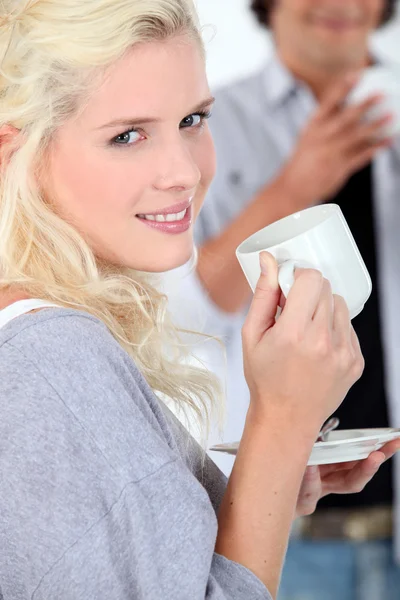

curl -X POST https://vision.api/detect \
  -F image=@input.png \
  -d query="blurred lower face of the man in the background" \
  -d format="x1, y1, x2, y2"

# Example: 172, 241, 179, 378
272, 0, 386, 68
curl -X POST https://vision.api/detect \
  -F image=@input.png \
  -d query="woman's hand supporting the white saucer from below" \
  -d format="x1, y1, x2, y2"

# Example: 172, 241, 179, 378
296, 440, 400, 518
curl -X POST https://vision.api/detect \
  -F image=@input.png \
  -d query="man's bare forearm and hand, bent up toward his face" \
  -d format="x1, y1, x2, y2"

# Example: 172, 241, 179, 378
197, 79, 391, 313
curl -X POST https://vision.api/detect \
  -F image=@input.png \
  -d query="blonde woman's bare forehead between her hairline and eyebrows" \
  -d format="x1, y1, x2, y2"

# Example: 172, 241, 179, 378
78, 36, 210, 126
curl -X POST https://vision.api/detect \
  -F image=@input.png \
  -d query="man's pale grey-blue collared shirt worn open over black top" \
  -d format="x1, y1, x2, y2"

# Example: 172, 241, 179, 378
163, 50, 400, 556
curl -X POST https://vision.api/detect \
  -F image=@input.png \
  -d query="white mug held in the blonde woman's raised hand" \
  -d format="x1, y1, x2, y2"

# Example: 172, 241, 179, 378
236, 204, 372, 319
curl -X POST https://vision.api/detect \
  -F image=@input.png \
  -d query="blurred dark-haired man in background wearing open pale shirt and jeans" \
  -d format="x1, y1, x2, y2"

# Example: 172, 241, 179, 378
168, 0, 400, 600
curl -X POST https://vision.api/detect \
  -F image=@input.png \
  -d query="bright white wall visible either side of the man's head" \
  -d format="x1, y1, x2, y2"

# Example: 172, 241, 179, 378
196, 0, 400, 87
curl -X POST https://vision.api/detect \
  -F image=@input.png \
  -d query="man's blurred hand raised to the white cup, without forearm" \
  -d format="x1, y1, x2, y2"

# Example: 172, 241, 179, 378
279, 77, 391, 210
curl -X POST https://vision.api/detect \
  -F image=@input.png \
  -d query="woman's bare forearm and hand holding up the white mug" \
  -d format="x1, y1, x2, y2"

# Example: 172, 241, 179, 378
222, 253, 364, 597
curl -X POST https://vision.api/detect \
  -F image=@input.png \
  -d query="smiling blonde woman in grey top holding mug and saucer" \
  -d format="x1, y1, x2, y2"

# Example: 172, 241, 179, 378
0, 0, 397, 600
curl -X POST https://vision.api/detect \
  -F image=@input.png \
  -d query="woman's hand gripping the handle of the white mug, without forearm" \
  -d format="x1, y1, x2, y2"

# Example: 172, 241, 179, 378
242, 252, 364, 439
